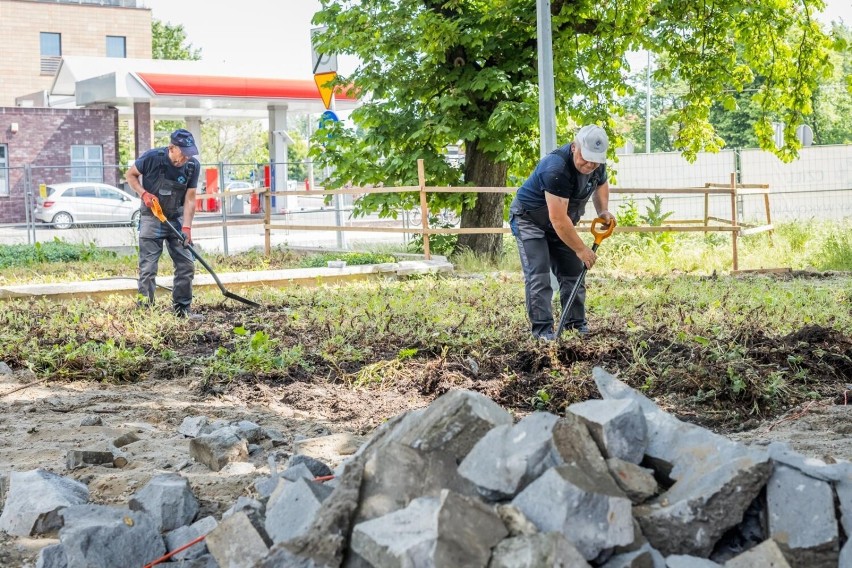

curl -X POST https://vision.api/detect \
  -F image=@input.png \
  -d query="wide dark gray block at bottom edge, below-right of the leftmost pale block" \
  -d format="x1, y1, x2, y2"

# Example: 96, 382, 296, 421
59, 505, 166, 568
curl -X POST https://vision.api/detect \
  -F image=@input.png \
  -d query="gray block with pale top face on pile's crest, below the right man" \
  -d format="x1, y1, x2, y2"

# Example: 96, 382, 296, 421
568, 399, 648, 464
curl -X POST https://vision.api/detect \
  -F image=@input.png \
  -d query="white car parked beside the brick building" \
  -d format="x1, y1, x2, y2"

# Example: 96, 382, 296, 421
35, 181, 142, 229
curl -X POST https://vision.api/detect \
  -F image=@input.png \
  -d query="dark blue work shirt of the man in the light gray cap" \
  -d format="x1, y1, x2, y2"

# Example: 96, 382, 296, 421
515, 144, 607, 215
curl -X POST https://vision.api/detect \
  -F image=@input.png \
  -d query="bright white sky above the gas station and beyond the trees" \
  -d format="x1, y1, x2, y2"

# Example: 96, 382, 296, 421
139, 0, 852, 79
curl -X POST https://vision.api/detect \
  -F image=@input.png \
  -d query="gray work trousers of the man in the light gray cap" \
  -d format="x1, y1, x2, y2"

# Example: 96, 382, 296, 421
509, 203, 587, 339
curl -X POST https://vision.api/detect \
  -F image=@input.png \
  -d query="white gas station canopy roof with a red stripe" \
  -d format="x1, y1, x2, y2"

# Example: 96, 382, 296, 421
49, 56, 358, 119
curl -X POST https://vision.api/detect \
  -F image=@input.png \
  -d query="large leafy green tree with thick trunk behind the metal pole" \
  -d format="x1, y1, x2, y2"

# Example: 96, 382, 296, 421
314, 0, 829, 254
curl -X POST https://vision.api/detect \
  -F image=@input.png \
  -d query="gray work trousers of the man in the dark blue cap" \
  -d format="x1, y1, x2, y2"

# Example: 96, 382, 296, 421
139, 215, 195, 313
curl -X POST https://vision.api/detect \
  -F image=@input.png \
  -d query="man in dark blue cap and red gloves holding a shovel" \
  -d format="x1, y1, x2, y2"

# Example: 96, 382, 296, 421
127, 129, 201, 320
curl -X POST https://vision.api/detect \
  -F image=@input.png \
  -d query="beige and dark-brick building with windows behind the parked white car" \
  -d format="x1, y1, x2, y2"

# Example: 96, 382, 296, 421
0, 0, 151, 223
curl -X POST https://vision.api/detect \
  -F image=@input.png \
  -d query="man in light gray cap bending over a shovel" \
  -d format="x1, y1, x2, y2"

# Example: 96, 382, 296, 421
509, 124, 614, 340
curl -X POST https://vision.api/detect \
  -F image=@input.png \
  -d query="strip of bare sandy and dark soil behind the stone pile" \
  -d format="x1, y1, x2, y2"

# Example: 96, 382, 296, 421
0, 327, 852, 567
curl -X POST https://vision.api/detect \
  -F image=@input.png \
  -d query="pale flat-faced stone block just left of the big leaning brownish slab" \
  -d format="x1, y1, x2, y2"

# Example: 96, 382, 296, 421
265, 478, 332, 543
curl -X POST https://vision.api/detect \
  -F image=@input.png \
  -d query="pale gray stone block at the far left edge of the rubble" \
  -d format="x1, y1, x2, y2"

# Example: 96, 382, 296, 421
0, 469, 89, 536
